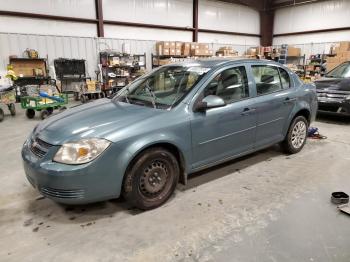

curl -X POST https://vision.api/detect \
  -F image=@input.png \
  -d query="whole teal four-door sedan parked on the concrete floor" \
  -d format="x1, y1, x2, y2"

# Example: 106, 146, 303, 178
22, 59, 317, 209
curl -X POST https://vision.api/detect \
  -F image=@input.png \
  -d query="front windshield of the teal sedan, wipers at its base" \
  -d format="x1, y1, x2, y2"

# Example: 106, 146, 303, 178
114, 65, 210, 109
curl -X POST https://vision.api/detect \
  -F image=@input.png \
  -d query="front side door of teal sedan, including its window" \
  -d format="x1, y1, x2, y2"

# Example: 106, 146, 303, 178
191, 66, 257, 169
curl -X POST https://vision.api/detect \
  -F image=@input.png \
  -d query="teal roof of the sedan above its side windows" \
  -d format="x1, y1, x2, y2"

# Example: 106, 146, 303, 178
169, 57, 282, 69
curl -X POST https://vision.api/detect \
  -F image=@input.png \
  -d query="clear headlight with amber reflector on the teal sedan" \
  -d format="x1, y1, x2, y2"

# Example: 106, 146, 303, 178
53, 138, 111, 165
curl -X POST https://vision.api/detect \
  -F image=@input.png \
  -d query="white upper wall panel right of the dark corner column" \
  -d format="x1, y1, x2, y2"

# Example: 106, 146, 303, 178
274, 0, 350, 34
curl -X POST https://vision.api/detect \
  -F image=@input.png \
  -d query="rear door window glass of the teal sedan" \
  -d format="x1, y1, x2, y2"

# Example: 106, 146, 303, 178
252, 65, 282, 95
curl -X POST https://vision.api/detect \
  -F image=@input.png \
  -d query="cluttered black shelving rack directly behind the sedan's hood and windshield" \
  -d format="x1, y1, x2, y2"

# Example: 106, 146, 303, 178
100, 51, 146, 95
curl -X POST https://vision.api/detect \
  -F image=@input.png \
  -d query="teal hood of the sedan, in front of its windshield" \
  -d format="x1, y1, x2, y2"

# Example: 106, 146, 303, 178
34, 99, 164, 145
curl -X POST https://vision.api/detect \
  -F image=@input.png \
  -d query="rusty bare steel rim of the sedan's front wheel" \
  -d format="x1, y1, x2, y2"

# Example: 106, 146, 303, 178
140, 161, 168, 196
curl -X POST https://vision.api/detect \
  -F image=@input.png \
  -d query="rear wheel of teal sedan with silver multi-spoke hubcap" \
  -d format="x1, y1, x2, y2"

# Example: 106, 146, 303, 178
281, 116, 309, 154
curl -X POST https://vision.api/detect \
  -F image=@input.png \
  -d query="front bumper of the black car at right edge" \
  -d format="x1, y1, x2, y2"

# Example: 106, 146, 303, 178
318, 98, 350, 116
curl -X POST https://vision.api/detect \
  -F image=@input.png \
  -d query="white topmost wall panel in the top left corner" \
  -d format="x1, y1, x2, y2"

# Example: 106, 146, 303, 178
0, 0, 96, 19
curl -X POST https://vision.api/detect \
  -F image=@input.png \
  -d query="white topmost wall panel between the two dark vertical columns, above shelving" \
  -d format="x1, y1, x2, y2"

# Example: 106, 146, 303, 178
103, 0, 193, 27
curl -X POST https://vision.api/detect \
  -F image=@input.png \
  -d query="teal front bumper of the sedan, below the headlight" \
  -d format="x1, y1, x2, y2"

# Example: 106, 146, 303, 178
22, 138, 122, 204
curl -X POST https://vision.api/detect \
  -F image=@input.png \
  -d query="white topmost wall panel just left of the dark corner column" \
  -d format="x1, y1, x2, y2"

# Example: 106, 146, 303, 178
198, 0, 260, 34
